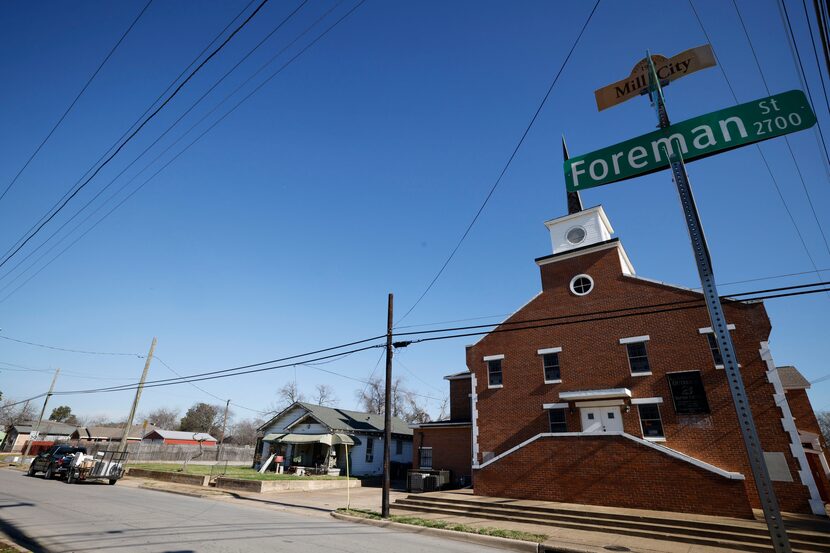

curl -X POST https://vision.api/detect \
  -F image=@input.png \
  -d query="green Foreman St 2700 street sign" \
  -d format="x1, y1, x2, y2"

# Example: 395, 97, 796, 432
565, 90, 816, 192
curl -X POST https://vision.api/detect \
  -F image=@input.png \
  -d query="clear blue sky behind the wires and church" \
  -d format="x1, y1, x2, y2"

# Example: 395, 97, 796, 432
0, 0, 830, 417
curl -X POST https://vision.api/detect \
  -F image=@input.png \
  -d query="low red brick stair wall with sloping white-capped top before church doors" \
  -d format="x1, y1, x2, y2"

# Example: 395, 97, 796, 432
475, 436, 752, 518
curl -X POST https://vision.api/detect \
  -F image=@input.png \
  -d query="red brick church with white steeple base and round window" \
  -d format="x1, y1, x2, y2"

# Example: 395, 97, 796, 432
464, 207, 826, 517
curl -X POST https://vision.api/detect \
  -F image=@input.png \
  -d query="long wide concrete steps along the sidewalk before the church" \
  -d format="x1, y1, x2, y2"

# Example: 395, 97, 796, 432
393, 493, 830, 553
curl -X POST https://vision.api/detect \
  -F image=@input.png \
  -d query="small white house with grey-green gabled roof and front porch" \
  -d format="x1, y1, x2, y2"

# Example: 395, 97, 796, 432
259, 402, 412, 476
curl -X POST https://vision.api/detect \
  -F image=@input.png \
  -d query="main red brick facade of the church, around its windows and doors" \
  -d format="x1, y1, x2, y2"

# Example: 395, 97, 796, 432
467, 248, 809, 512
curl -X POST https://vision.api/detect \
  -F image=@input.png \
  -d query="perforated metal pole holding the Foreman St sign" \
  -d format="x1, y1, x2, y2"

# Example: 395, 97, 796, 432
646, 53, 791, 553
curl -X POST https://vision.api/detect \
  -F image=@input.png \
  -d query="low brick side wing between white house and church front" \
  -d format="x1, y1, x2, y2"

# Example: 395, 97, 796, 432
412, 424, 473, 481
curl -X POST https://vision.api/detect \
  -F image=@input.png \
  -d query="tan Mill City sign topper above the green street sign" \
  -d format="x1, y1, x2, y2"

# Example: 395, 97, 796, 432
594, 44, 716, 111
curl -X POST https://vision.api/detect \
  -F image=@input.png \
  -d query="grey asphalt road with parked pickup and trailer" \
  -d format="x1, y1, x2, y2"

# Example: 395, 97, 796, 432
0, 470, 495, 553
